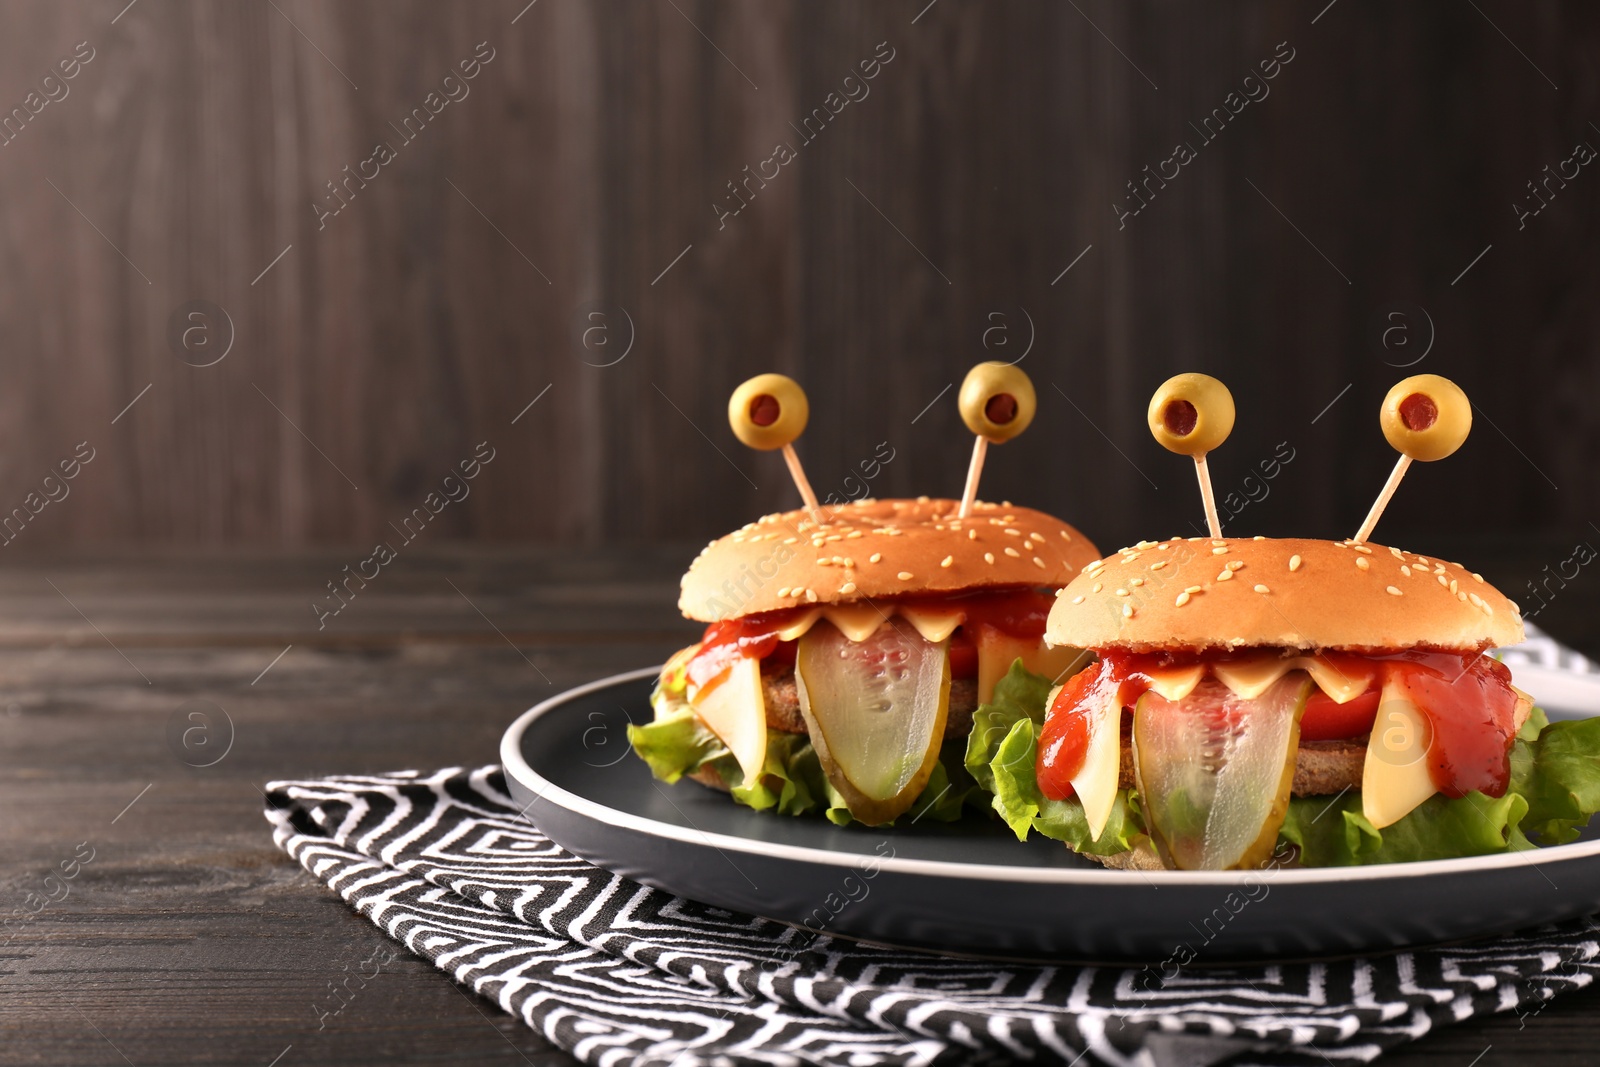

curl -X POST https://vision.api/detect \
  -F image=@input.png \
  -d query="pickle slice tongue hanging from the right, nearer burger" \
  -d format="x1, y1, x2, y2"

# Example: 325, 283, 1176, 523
1133, 681, 1310, 870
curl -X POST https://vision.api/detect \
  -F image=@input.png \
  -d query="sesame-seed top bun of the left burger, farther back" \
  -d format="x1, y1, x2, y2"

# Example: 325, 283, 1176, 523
678, 496, 1099, 622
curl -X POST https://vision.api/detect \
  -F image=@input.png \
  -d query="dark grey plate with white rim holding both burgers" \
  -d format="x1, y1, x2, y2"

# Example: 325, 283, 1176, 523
501, 669, 1600, 961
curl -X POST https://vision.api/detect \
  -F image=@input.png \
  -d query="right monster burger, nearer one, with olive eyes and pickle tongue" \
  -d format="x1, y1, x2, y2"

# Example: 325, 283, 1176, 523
978, 376, 1600, 870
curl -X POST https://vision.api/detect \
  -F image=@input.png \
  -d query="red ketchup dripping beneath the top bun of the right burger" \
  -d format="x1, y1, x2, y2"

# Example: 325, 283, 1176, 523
1035, 649, 1517, 800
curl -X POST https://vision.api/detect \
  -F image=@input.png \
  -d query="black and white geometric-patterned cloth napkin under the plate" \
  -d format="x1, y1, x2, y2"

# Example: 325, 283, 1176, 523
266, 766, 1600, 1067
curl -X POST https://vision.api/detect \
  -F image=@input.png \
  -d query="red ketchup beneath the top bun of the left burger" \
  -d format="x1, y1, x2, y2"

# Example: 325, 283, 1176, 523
688, 589, 1056, 688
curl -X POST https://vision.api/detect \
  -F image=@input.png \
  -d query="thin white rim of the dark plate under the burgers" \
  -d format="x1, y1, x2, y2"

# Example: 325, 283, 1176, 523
501, 665, 1600, 888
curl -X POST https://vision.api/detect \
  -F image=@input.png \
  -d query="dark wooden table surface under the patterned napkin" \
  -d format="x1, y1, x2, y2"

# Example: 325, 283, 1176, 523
0, 549, 1600, 1067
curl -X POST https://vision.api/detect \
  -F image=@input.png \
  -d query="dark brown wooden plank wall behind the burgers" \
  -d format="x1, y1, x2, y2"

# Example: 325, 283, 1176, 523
0, 0, 1600, 552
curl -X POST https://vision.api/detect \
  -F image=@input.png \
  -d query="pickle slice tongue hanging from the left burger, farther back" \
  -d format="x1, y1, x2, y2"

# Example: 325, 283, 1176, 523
795, 617, 950, 824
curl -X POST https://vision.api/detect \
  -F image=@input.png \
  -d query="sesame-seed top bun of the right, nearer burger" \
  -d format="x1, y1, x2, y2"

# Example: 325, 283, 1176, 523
1045, 537, 1523, 651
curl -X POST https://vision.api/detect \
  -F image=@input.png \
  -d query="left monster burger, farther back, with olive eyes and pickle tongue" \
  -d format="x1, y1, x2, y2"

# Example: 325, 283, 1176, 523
629, 368, 1099, 825
